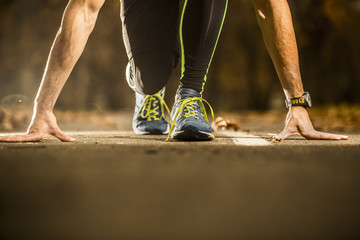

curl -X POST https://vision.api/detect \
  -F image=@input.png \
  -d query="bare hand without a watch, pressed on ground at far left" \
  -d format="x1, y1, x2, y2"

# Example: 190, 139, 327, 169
0, 112, 76, 142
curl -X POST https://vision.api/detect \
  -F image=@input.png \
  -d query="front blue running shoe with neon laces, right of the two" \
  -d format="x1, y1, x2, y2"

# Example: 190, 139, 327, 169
167, 89, 214, 141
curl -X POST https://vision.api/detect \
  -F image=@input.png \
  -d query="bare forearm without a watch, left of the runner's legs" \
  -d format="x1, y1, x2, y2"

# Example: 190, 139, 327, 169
34, 1, 97, 113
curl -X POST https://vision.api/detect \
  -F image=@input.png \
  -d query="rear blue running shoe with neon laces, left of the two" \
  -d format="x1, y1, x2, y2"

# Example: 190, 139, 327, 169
133, 90, 170, 134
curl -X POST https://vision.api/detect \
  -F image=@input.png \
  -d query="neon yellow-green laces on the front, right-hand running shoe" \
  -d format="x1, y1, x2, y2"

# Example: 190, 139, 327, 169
166, 97, 214, 141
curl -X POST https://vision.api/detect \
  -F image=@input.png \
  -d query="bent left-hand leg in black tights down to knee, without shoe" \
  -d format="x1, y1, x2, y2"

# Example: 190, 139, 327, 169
121, 0, 179, 95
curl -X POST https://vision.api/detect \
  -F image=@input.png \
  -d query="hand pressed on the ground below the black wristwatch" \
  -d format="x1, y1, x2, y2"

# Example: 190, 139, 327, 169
273, 107, 348, 141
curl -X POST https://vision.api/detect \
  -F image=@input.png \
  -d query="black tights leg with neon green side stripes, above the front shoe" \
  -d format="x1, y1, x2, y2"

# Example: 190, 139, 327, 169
180, 0, 228, 94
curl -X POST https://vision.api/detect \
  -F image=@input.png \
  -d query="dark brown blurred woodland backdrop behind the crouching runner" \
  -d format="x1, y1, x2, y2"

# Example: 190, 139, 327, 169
0, 0, 360, 130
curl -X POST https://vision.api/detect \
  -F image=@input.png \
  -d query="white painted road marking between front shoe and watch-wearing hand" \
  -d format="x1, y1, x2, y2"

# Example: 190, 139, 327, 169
221, 131, 271, 146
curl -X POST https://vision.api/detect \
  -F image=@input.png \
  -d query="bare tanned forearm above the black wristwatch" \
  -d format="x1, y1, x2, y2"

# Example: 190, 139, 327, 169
253, 0, 304, 98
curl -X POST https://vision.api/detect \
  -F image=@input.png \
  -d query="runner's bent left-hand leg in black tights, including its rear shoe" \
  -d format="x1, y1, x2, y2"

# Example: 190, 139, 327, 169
121, 0, 179, 134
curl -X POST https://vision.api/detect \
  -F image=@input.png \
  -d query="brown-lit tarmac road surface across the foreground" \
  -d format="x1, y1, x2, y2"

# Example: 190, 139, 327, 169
0, 132, 360, 239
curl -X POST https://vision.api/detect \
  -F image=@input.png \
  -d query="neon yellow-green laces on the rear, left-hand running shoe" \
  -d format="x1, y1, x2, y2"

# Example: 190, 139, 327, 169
140, 93, 170, 122
